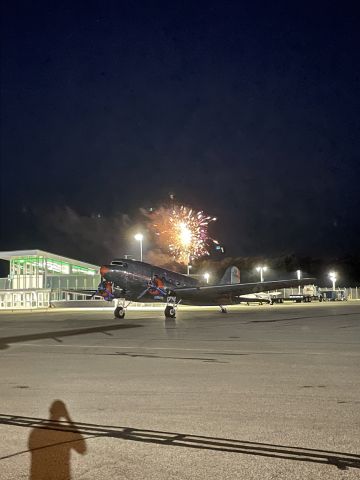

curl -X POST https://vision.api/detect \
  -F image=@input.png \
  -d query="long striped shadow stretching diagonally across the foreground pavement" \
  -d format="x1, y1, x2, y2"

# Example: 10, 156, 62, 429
0, 414, 360, 470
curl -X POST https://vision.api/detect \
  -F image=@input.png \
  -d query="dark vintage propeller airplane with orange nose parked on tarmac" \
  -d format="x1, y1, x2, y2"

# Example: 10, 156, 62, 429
71, 258, 314, 318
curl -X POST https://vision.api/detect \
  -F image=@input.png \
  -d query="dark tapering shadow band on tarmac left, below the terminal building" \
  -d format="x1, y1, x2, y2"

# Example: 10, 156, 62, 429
0, 324, 142, 350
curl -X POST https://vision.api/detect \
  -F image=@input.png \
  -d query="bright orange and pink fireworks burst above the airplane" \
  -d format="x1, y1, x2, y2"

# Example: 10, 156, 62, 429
152, 205, 219, 264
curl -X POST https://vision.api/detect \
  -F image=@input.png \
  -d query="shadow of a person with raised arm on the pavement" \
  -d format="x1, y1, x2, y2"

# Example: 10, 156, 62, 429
28, 400, 86, 480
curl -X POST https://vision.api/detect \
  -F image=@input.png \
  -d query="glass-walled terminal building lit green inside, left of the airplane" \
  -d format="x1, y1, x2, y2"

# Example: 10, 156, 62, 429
0, 250, 100, 308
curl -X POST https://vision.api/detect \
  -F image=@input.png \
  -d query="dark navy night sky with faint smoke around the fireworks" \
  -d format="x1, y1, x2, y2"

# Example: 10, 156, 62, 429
0, 1, 360, 268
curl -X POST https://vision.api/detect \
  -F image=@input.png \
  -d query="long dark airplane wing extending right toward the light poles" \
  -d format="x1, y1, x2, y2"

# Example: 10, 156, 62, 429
174, 278, 315, 305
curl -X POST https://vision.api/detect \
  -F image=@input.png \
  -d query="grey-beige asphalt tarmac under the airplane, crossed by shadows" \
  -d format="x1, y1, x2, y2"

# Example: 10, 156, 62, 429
0, 302, 360, 480
